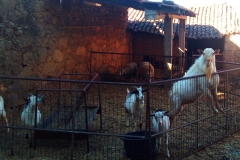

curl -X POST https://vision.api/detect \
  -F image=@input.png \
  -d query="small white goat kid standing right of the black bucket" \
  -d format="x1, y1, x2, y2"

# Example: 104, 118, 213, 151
152, 109, 170, 158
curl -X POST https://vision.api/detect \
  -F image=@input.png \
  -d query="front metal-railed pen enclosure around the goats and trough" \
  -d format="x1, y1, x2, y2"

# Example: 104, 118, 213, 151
0, 62, 240, 160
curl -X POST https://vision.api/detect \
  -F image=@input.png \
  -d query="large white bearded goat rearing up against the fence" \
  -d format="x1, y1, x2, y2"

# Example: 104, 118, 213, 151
168, 48, 223, 125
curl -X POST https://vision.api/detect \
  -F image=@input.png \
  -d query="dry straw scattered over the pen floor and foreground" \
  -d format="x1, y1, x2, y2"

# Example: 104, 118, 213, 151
0, 81, 240, 160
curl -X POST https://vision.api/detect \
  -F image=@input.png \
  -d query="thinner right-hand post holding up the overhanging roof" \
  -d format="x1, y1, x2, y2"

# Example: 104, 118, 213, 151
179, 19, 186, 72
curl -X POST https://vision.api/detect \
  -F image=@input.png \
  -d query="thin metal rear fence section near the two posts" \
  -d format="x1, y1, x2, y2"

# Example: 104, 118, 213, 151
89, 50, 188, 82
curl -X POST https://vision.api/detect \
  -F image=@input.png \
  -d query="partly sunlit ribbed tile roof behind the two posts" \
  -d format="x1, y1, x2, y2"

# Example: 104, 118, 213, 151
128, 3, 240, 39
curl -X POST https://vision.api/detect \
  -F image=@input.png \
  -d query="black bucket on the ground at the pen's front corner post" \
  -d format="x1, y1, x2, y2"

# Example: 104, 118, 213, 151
121, 131, 156, 160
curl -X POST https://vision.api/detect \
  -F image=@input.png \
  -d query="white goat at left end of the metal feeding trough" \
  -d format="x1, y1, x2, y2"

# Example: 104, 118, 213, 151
21, 94, 43, 147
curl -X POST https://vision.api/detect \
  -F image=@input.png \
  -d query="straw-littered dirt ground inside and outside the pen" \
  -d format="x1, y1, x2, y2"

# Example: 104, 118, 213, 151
0, 79, 240, 160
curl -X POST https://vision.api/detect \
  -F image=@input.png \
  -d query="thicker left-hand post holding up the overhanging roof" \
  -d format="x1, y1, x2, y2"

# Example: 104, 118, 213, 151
163, 14, 173, 79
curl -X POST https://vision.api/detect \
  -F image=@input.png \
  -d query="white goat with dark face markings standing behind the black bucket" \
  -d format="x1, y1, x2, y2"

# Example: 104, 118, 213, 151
124, 87, 145, 131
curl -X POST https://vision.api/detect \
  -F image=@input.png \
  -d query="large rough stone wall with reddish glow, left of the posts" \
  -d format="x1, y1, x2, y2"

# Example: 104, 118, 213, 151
0, 0, 131, 106
